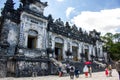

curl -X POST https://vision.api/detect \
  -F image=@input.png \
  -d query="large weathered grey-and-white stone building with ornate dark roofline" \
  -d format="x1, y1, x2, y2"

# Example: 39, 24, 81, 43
0, 0, 107, 77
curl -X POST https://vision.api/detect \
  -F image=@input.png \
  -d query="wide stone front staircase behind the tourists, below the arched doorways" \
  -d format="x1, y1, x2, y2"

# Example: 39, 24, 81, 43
50, 58, 106, 74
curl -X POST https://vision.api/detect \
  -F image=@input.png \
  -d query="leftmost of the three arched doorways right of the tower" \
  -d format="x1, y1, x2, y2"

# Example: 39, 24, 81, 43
55, 37, 64, 61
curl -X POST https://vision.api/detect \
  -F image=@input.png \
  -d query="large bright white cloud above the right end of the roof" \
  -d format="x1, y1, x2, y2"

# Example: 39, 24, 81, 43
71, 8, 120, 34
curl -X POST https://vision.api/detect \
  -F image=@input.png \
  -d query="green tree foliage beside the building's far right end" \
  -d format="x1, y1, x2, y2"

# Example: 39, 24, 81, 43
101, 33, 120, 60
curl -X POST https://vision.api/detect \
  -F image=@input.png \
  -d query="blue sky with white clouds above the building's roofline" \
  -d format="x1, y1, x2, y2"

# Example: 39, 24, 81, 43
0, 0, 120, 35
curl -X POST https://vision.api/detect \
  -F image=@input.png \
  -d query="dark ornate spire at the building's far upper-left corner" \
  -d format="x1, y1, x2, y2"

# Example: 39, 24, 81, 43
1, 0, 14, 16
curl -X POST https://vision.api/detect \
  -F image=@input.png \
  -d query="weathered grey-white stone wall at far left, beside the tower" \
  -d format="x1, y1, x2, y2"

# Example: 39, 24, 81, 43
0, 19, 19, 77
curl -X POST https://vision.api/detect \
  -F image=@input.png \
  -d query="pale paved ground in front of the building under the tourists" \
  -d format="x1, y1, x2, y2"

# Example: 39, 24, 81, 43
0, 70, 118, 80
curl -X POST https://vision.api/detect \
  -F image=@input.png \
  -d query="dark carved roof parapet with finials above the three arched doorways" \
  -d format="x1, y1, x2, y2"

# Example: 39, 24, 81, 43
48, 18, 102, 44
